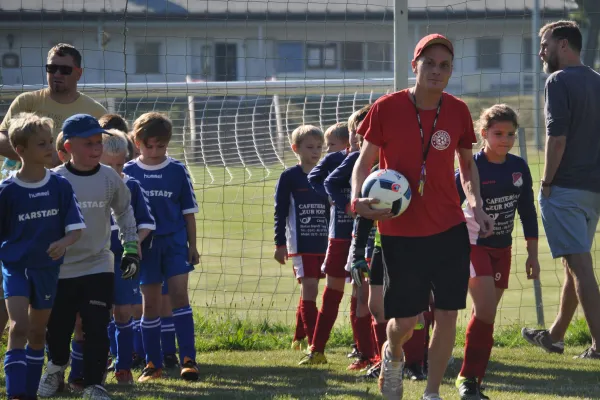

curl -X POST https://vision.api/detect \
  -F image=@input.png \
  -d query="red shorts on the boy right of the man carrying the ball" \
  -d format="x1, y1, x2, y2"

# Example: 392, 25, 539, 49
471, 245, 512, 289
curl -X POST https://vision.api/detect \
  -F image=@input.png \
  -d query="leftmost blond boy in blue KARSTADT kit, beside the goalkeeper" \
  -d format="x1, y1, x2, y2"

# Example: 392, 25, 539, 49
0, 113, 85, 399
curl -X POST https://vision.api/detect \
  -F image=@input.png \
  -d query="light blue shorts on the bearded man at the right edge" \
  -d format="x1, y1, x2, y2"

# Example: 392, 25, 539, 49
538, 186, 600, 258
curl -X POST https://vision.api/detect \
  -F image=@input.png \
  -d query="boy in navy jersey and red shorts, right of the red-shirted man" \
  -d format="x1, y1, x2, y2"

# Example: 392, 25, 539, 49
456, 104, 540, 399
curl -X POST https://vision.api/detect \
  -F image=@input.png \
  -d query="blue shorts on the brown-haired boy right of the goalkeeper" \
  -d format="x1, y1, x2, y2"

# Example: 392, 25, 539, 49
140, 229, 194, 285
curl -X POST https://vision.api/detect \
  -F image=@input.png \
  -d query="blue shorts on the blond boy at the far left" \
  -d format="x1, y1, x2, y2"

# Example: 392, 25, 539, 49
2, 266, 60, 310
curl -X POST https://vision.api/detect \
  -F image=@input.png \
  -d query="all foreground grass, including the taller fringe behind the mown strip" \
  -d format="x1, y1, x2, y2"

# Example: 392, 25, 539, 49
0, 312, 600, 400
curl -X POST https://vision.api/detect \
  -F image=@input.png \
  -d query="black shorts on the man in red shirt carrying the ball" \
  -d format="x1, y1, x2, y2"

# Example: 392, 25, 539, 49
381, 223, 471, 319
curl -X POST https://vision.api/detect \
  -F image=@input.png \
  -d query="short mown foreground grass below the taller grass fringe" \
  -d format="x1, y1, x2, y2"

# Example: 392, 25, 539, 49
22, 347, 600, 400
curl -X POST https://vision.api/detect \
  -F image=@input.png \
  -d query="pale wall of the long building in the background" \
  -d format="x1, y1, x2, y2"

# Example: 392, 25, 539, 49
0, 20, 544, 93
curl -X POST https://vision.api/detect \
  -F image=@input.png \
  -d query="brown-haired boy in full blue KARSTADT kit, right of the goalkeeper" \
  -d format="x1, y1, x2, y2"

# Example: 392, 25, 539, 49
123, 112, 200, 382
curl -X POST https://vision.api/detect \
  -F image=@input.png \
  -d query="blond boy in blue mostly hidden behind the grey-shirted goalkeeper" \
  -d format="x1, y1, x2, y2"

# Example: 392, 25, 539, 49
101, 129, 156, 385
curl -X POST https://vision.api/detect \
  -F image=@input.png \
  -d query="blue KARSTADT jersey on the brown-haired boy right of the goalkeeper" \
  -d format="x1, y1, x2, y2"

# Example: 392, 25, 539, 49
123, 157, 198, 235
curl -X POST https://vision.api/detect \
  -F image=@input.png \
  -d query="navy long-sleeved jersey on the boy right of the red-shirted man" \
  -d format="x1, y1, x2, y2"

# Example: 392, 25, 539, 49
456, 151, 538, 248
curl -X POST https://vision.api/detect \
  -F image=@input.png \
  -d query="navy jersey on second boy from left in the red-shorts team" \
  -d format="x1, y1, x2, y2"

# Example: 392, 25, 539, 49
308, 150, 353, 240
